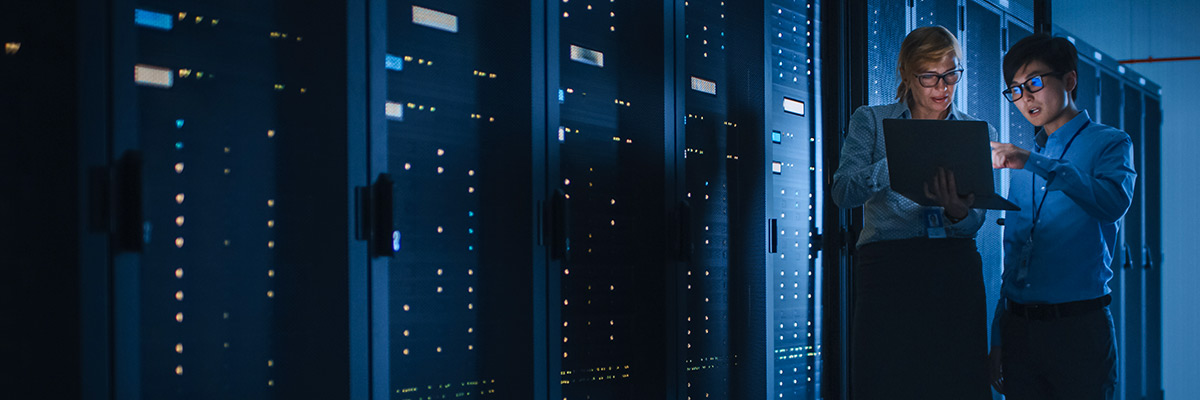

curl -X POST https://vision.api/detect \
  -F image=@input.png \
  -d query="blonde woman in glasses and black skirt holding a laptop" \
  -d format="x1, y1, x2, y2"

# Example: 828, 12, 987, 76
833, 26, 996, 400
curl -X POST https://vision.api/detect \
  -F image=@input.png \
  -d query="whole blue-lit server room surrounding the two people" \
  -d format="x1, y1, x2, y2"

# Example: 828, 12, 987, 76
0, 0, 1200, 400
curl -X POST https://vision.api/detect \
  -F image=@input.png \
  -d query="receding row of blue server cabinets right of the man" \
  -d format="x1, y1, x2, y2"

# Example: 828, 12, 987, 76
1055, 26, 1163, 399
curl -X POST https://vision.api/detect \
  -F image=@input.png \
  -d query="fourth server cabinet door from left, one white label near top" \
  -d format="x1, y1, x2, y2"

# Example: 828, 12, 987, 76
547, 0, 676, 400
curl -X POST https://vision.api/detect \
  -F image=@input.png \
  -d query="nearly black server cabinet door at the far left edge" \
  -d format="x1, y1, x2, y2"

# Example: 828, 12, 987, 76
0, 1, 87, 399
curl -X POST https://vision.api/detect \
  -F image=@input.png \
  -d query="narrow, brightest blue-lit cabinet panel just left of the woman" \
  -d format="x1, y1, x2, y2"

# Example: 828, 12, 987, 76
763, 1, 824, 399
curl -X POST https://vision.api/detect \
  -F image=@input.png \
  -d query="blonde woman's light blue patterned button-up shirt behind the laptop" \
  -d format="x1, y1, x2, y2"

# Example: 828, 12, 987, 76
832, 102, 996, 246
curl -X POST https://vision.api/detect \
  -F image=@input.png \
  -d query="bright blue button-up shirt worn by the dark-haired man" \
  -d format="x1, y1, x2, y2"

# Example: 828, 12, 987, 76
991, 111, 1138, 346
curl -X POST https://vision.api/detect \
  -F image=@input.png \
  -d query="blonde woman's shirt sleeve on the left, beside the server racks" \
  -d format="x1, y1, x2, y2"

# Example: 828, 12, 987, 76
833, 107, 890, 208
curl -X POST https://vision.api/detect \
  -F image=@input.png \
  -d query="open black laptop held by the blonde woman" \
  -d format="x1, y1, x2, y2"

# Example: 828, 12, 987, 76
883, 119, 1021, 211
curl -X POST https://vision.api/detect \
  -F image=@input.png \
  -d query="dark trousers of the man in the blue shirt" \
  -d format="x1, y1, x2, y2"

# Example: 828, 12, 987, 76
1001, 303, 1117, 400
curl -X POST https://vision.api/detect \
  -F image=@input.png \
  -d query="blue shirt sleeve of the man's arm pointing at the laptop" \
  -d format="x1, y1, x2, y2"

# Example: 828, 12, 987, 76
1025, 135, 1138, 222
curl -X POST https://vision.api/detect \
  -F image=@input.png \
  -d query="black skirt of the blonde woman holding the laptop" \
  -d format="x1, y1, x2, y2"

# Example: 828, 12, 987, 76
850, 239, 991, 400
